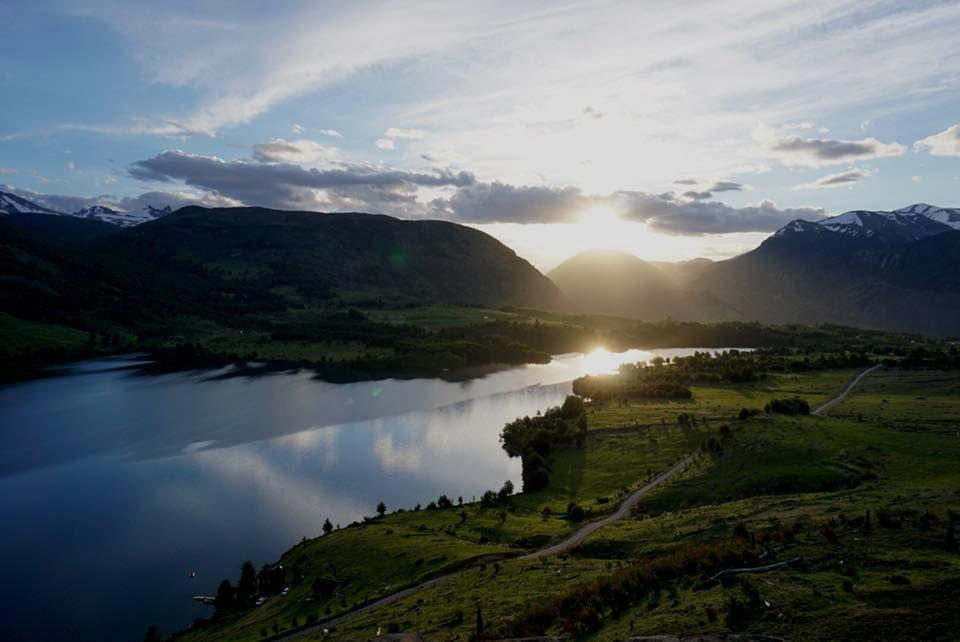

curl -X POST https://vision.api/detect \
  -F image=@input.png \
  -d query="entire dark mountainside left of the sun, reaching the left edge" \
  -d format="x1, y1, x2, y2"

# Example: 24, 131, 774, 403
0, 207, 566, 337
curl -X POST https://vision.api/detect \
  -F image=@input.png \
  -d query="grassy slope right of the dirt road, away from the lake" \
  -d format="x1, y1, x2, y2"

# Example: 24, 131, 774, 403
284, 372, 960, 640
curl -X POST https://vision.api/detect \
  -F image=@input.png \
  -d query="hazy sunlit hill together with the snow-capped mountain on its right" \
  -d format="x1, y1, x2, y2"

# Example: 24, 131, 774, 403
550, 203, 960, 335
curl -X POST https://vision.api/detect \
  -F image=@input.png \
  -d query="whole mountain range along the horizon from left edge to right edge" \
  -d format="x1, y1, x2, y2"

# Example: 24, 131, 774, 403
0, 193, 960, 336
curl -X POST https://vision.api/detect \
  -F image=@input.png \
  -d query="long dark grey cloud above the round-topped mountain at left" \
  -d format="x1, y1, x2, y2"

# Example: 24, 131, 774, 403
128, 150, 476, 214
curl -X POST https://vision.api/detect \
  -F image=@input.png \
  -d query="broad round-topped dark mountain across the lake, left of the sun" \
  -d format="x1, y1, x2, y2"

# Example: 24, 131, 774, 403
106, 206, 565, 309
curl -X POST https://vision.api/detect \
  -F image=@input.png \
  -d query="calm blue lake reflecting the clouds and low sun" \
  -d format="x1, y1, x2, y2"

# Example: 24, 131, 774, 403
0, 349, 712, 640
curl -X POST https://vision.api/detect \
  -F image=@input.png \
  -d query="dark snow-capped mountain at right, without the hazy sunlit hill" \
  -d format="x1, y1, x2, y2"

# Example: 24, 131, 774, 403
688, 204, 960, 335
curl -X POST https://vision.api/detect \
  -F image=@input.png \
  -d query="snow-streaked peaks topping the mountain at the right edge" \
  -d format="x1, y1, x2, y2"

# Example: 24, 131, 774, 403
775, 203, 960, 242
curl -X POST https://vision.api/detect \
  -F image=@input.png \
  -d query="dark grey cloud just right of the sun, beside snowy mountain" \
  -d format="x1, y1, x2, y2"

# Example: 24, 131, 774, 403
612, 192, 825, 235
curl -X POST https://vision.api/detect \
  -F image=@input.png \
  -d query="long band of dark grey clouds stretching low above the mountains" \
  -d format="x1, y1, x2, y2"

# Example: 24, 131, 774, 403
120, 146, 824, 235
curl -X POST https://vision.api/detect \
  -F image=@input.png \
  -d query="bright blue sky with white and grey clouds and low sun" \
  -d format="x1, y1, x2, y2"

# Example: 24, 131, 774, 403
0, 0, 960, 269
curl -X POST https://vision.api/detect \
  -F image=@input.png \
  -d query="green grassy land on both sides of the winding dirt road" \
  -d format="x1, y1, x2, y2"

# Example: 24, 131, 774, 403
174, 370, 960, 641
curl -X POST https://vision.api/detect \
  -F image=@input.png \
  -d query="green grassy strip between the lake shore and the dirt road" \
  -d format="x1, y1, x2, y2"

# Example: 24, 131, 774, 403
174, 426, 709, 640
